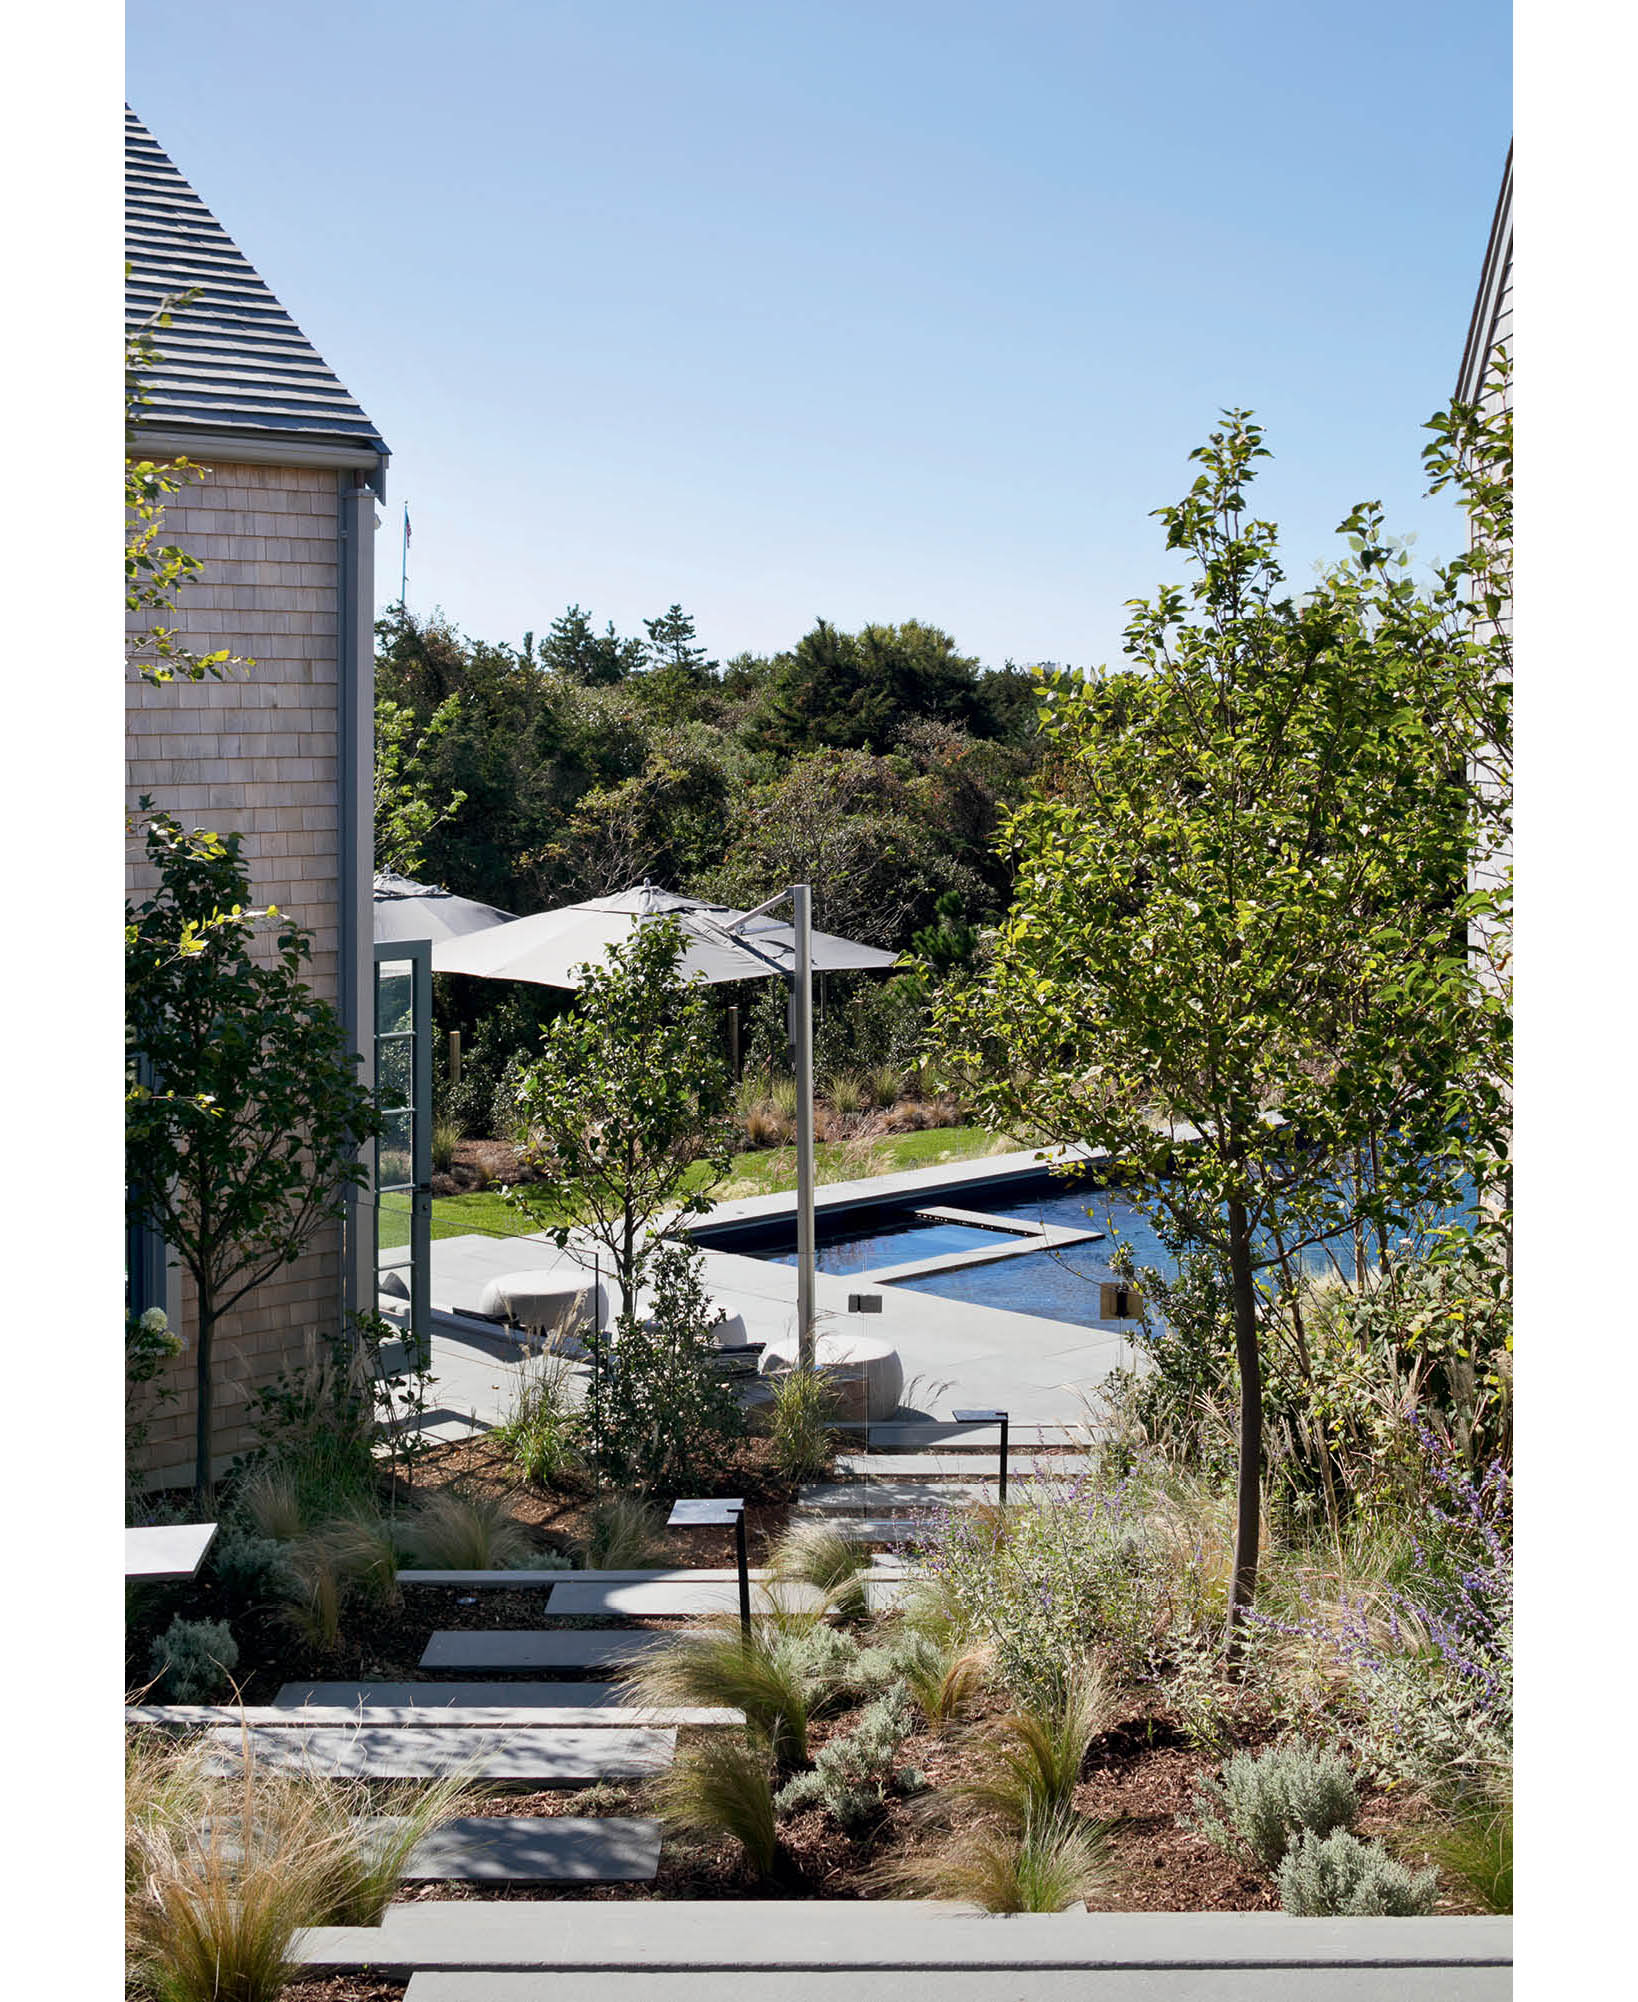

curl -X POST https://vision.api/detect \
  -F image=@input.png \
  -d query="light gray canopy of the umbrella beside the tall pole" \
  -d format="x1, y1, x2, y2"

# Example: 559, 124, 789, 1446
421, 883, 897, 987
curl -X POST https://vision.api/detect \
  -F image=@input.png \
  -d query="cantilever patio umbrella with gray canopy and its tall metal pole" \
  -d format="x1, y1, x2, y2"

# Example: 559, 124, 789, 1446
433, 883, 897, 1361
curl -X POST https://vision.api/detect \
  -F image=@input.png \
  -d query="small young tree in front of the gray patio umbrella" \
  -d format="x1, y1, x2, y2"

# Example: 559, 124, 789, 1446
509, 919, 735, 1313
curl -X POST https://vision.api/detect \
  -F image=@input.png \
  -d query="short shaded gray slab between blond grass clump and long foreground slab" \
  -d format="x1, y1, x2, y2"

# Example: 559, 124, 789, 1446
366, 1814, 661, 1884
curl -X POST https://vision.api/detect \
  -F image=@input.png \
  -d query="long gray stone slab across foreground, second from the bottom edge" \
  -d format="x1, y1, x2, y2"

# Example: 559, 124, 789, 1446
298, 1898, 1512, 1994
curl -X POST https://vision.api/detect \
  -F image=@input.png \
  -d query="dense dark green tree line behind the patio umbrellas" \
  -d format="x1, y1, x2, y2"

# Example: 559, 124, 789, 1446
376, 605, 1037, 947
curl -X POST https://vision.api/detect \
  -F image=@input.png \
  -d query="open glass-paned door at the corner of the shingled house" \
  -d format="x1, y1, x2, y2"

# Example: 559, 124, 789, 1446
374, 939, 433, 1369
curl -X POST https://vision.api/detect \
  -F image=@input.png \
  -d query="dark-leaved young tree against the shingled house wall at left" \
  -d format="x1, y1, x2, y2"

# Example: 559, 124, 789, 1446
126, 803, 380, 1495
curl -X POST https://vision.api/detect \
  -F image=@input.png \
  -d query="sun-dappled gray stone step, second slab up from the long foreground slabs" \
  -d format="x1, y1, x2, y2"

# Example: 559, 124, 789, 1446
208, 1726, 677, 1788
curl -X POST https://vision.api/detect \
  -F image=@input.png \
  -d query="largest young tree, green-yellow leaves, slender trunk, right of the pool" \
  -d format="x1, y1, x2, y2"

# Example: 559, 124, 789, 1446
939, 412, 1482, 1644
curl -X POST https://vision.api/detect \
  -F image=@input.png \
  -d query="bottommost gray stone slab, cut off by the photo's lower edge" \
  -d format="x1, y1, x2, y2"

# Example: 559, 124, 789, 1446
404, 1968, 1512, 2002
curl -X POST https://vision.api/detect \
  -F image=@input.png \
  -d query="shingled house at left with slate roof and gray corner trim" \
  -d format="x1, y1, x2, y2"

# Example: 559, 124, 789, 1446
126, 110, 386, 1481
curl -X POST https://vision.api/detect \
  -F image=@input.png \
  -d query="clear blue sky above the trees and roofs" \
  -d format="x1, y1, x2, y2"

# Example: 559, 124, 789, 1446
128, 0, 1510, 663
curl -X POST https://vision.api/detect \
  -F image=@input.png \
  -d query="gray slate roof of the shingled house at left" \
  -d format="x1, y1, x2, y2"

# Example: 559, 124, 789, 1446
124, 106, 386, 462
